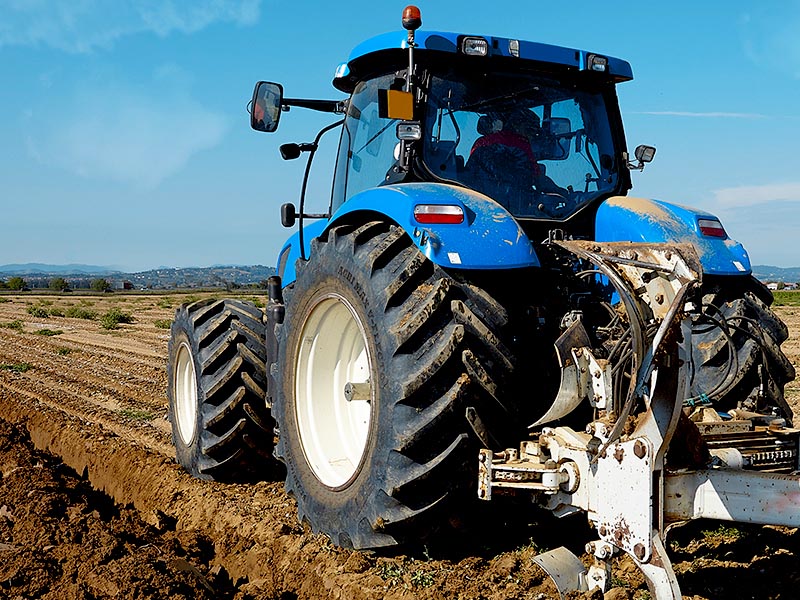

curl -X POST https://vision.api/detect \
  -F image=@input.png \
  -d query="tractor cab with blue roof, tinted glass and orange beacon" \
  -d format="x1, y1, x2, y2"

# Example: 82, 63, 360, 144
253, 7, 654, 234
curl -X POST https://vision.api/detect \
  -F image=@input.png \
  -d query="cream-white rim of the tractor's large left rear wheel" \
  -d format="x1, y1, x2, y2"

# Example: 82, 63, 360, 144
295, 294, 374, 488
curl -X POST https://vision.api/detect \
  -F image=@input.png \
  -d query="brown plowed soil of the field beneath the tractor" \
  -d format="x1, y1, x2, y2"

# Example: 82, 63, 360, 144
0, 294, 800, 600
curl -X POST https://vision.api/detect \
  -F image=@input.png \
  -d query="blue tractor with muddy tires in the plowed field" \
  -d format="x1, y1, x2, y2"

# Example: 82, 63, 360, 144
169, 7, 797, 596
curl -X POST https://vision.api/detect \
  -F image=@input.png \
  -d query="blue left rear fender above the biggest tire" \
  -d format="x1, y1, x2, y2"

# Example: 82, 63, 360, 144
278, 183, 540, 285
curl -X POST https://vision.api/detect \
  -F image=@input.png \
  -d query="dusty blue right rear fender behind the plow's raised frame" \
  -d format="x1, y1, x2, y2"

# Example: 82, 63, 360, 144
595, 196, 752, 275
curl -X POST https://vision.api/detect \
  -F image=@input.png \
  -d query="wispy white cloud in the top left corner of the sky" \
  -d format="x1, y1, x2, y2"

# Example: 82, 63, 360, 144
0, 0, 261, 53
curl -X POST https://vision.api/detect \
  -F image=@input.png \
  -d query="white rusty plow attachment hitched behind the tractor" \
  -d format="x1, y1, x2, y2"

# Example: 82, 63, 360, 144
478, 241, 800, 600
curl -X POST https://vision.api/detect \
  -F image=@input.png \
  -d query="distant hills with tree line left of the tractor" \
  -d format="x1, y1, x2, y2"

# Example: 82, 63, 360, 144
0, 263, 275, 289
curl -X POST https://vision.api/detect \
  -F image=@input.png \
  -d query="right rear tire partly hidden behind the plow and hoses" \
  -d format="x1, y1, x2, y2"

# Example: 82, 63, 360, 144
691, 277, 795, 420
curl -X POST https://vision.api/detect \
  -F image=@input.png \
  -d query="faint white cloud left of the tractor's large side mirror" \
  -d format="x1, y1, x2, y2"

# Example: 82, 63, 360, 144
28, 86, 229, 188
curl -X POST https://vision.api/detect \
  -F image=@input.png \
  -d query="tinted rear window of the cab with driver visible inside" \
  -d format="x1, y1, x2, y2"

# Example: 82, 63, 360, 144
423, 71, 619, 219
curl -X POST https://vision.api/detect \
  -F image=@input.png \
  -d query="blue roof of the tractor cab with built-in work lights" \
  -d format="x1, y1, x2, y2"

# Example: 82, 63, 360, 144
333, 31, 633, 92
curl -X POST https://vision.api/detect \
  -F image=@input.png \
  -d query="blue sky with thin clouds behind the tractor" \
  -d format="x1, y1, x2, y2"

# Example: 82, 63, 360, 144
0, 0, 800, 270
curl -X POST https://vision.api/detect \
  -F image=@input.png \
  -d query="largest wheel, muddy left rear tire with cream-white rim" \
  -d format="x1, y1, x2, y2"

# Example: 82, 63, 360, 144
273, 222, 512, 548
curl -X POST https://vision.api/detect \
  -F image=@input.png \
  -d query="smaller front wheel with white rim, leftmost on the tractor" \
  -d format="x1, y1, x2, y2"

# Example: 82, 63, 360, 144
167, 299, 274, 481
